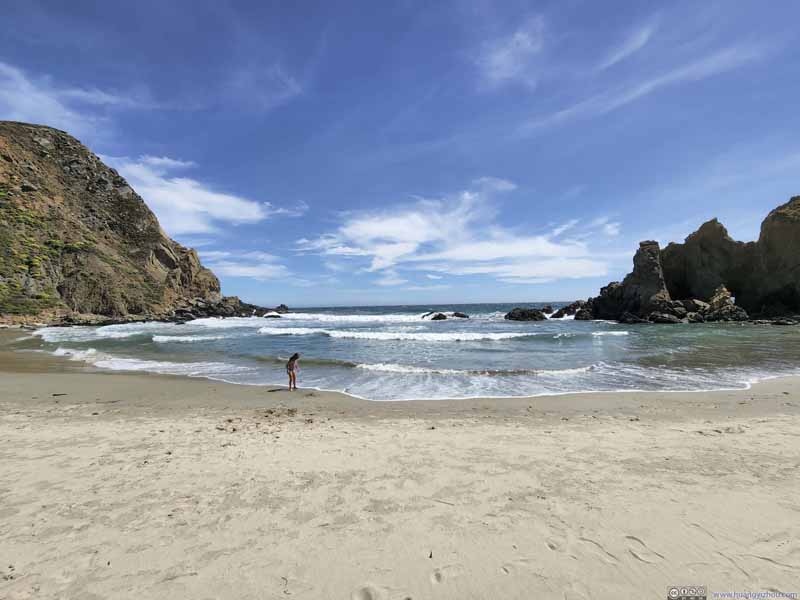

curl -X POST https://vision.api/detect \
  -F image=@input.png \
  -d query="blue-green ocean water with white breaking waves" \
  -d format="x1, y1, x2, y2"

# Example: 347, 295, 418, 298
28, 303, 800, 400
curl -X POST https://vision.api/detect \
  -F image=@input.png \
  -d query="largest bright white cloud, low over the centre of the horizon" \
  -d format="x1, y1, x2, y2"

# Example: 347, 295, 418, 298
297, 182, 607, 285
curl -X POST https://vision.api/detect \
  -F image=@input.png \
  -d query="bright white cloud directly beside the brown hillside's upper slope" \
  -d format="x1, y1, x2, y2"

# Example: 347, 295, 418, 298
101, 156, 307, 235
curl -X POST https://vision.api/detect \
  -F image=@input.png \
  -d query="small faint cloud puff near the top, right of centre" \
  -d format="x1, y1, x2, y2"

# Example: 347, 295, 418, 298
475, 17, 545, 88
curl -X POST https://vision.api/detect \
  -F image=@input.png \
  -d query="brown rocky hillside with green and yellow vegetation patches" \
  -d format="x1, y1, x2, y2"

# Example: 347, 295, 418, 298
0, 121, 280, 320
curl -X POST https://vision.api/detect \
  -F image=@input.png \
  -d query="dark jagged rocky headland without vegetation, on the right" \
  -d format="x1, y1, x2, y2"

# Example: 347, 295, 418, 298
553, 196, 800, 325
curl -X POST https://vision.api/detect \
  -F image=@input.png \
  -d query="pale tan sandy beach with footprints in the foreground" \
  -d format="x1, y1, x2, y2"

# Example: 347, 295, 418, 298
0, 330, 800, 600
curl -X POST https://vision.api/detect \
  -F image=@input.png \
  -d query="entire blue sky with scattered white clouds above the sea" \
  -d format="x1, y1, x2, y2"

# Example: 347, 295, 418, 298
0, 0, 800, 306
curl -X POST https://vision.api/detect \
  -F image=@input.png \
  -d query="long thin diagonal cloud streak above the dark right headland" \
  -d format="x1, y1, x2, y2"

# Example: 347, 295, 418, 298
522, 44, 768, 133
